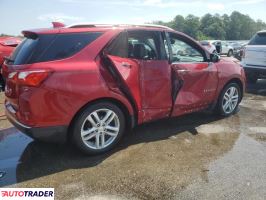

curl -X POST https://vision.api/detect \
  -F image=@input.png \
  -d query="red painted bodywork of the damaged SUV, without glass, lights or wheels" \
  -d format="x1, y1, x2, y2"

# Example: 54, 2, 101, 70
6, 27, 245, 133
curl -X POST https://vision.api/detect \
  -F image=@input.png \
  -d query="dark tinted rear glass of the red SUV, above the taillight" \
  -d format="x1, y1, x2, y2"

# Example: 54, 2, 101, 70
9, 32, 102, 65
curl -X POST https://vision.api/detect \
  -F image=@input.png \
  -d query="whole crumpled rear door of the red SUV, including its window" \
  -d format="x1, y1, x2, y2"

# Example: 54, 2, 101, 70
102, 30, 172, 122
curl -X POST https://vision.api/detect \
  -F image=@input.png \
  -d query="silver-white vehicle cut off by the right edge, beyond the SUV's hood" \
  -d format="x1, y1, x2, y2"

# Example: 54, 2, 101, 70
241, 31, 266, 83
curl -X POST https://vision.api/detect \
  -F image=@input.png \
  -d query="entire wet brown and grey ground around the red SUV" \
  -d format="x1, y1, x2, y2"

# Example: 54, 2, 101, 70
0, 80, 266, 200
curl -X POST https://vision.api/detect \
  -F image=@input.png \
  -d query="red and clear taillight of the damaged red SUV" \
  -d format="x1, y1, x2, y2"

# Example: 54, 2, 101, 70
8, 70, 51, 87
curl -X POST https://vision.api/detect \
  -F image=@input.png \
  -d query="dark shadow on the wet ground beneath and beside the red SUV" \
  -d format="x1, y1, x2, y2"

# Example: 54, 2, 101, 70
0, 112, 222, 186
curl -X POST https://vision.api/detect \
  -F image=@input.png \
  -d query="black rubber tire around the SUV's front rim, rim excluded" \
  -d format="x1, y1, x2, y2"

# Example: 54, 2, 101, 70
217, 83, 242, 117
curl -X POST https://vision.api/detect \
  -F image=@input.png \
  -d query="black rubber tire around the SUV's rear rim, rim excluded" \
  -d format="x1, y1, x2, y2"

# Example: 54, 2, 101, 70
72, 102, 126, 155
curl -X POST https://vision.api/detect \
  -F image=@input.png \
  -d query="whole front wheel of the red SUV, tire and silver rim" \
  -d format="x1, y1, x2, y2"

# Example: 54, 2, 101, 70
217, 83, 242, 117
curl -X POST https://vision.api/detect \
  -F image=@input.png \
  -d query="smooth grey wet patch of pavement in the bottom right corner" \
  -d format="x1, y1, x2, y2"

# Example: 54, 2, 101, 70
176, 134, 266, 200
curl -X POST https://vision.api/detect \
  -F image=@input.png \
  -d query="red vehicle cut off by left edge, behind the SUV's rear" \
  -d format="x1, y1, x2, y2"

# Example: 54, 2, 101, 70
0, 37, 21, 91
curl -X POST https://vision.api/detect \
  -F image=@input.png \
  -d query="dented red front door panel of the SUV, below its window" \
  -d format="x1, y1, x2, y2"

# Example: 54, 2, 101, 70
172, 62, 218, 116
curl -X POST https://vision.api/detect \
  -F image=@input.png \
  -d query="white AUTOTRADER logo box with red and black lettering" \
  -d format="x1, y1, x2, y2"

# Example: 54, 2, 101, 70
0, 188, 54, 200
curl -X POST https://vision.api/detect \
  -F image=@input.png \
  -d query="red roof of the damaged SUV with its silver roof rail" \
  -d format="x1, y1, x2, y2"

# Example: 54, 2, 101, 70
22, 23, 174, 35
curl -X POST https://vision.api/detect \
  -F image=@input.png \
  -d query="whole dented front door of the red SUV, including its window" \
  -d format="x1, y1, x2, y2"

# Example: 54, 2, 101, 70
166, 32, 218, 116
